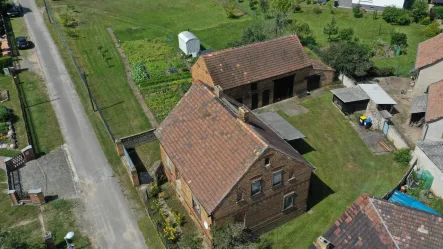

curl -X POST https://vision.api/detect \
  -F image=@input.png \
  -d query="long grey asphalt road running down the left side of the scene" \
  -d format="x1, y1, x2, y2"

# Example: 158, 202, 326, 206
21, 0, 147, 249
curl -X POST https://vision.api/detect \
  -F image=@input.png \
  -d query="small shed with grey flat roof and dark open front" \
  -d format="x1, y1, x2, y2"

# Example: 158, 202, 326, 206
331, 86, 369, 114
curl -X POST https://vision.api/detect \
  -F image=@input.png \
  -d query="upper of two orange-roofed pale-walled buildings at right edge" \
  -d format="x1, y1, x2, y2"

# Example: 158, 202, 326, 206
414, 33, 443, 96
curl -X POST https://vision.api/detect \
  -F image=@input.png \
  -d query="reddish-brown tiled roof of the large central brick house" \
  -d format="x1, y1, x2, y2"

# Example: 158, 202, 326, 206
156, 82, 310, 214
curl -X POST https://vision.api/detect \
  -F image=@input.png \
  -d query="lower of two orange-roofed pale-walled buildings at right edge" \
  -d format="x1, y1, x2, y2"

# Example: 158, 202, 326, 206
423, 80, 443, 141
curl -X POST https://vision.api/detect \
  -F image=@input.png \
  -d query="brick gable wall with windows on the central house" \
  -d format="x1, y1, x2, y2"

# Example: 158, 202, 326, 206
213, 150, 311, 231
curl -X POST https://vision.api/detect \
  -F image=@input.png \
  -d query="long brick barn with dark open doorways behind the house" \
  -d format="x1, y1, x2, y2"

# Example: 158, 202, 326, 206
191, 35, 335, 109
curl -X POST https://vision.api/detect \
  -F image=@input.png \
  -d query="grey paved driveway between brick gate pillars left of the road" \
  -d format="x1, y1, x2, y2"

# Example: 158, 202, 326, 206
19, 148, 76, 198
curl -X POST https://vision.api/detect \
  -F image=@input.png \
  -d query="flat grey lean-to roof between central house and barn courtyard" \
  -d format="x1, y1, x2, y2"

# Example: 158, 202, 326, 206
257, 112, 306, 141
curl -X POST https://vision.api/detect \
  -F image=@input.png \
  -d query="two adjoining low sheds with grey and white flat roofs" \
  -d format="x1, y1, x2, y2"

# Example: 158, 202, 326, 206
331, 84, 397, 115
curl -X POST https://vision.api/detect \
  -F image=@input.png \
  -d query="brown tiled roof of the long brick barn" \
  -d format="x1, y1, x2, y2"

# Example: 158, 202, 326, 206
198, 35, 311, 90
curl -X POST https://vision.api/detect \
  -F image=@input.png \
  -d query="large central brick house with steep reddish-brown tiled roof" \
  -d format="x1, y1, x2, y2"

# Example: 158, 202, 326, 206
156, 82, 313, 239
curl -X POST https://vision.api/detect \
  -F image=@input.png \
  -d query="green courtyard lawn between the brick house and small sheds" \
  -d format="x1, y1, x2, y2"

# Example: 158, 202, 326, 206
265, 93, 407, 249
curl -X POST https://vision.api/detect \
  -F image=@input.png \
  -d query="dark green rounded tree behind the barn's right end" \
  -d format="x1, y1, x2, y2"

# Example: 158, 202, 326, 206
322, 41, 373, 77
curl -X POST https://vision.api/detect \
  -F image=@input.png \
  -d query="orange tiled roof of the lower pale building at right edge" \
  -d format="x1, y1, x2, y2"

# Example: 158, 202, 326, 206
426, 80, 443, 122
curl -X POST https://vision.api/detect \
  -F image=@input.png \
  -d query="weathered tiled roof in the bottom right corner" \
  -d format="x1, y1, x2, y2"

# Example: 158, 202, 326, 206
309, 194, 443, 249
